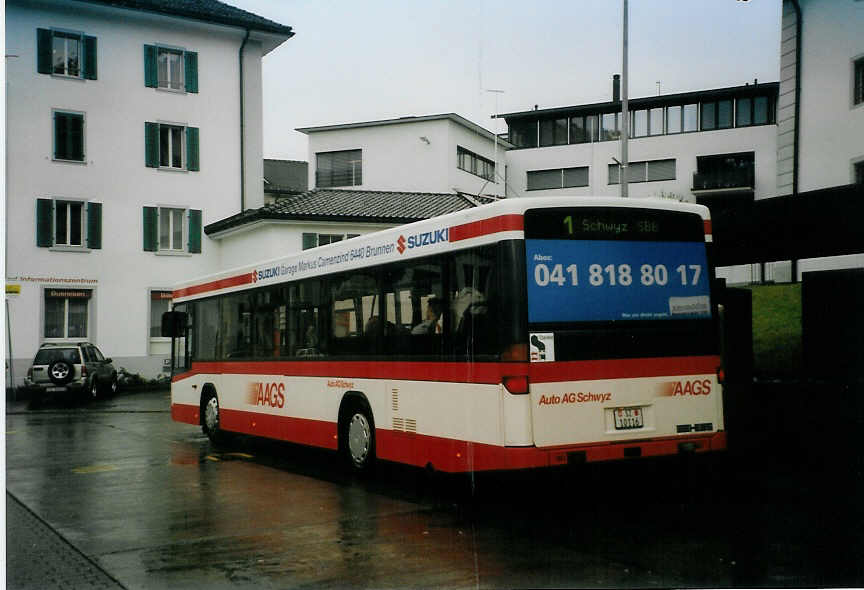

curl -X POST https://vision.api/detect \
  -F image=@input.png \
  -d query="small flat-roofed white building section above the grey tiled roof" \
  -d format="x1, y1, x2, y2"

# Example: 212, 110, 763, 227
297, 113, 511, 196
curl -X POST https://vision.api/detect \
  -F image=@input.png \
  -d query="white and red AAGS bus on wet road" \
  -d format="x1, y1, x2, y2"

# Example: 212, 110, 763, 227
165, 197, 726, 472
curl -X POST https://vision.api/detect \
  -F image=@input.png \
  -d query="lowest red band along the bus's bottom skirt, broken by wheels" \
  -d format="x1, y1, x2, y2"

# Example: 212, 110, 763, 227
171, 404, 726, 473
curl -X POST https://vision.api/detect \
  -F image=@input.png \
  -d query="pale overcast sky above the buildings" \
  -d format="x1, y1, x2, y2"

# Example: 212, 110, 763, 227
226, 0, 781, 160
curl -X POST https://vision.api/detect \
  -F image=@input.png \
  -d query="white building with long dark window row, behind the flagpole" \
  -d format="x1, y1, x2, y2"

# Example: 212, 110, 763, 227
500, 76, 778, 206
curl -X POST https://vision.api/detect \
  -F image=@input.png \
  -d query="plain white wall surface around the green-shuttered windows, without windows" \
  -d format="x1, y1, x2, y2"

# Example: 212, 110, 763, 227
6, 1, 276, 382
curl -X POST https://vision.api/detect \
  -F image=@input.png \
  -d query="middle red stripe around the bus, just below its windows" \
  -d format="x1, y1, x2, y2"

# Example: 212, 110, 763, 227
172, 356, 720, 384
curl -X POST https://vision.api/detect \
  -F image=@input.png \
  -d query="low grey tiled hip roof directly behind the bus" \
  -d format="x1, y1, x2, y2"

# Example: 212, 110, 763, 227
204, 189, 495, 235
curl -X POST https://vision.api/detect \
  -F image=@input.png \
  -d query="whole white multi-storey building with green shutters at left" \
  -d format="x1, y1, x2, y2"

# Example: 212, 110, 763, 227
4, 0, 293, 383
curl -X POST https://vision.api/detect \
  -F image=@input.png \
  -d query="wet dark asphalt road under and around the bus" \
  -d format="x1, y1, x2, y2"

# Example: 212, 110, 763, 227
6, 391, 864, 589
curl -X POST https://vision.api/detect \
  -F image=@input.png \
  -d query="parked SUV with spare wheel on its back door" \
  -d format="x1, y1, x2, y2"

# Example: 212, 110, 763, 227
24, 342, 117, 398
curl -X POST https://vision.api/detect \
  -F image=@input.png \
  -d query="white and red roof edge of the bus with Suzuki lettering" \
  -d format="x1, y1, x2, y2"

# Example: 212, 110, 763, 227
173, 197, 710, 303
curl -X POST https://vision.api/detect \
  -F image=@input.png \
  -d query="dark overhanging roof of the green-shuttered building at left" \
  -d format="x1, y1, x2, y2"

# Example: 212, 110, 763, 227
79, 0, 294, 37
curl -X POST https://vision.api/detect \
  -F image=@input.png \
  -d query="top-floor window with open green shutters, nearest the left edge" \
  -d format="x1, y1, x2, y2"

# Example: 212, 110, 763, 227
36, 29, 97, 80
